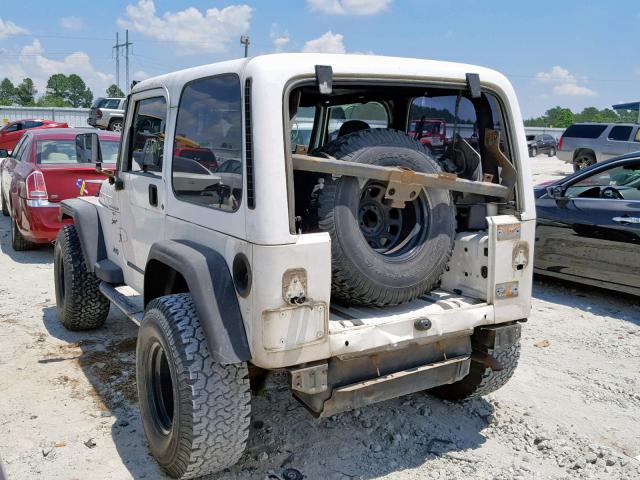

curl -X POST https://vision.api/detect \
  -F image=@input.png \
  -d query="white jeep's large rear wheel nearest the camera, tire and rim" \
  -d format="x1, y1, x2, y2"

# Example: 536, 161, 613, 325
136, 293, 251, 479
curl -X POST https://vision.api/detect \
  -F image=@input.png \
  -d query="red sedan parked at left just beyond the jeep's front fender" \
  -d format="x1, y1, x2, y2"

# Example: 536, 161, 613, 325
0, 128, 120, 250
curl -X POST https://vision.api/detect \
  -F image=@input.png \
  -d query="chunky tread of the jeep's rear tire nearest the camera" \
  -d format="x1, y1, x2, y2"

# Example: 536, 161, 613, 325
138, 293, 251, 479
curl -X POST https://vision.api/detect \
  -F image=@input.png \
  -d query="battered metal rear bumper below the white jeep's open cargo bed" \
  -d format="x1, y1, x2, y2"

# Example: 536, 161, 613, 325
289, 322, 520, 417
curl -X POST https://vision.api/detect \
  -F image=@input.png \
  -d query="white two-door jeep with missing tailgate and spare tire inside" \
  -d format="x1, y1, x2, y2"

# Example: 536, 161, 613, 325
55, 54, 535, 478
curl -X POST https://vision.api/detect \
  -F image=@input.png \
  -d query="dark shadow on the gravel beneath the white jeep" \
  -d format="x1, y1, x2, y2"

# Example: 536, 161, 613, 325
43, 307, 494, 480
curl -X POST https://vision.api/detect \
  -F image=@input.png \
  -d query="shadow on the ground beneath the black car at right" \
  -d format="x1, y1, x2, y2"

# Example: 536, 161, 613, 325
533, 274, 640, 326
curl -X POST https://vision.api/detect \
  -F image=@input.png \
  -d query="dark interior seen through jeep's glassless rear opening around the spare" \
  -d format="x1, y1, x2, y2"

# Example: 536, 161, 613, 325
288, 80, 513, 237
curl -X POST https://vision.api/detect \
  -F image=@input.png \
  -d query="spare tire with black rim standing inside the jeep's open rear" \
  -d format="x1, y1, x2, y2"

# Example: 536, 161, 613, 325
317, 129, 455, 306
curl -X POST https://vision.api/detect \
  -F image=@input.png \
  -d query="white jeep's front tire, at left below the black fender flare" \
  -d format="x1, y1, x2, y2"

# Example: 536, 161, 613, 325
53, 225, 110, 330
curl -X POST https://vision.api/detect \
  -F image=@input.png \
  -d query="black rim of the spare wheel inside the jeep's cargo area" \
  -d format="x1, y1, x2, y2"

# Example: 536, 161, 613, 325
358, 181, 429, 260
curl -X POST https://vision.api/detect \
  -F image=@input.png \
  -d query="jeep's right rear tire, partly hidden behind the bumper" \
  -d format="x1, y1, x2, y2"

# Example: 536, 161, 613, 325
430, 340, 520, 400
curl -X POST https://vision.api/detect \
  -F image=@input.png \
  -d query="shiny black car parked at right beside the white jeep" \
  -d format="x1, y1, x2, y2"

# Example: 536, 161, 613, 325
534, 153, 640, 295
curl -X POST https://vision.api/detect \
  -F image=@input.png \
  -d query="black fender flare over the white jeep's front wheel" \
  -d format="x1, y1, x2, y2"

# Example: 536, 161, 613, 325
60, 198, 107, 272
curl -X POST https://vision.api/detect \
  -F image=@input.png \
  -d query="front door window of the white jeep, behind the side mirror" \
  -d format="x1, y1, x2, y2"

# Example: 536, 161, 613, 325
124, 97, 167, 174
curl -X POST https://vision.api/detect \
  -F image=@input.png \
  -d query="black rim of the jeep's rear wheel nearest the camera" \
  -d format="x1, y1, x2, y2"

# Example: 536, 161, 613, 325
146, 341, 174, 435
